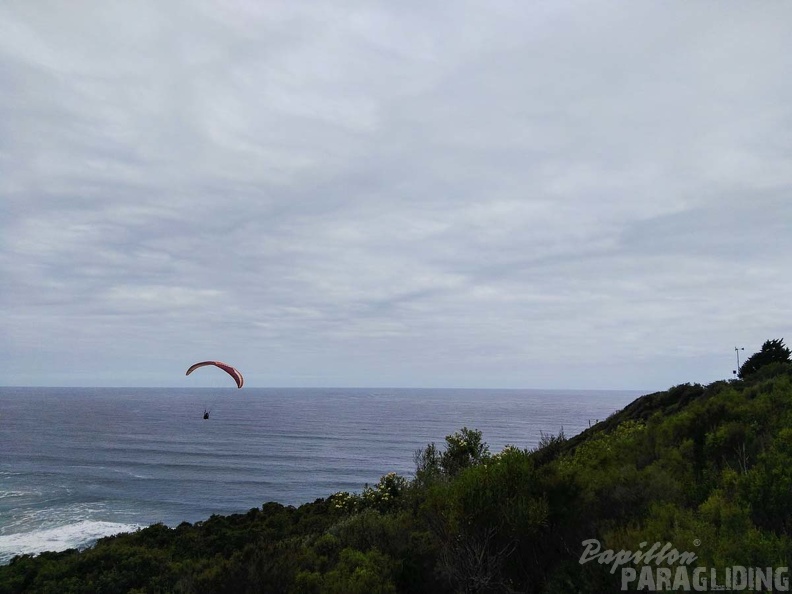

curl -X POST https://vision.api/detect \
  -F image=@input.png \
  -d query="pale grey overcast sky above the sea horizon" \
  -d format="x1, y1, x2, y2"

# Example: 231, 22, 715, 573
0, 0, 792, 391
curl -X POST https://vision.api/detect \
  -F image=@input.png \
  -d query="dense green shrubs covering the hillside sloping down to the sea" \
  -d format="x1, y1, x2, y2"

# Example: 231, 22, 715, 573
0, 345, 792, 594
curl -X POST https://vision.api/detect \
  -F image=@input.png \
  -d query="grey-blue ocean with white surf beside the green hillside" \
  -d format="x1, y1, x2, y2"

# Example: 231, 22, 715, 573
0, 388, 643, 563
